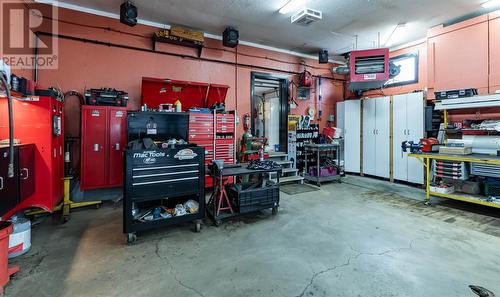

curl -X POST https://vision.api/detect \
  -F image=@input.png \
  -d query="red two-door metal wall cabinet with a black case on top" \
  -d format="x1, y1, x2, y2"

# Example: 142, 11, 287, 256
80, 105, 127, 190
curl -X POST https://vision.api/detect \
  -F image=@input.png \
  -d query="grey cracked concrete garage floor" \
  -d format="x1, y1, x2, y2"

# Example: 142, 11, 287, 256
6, 176, 500, 297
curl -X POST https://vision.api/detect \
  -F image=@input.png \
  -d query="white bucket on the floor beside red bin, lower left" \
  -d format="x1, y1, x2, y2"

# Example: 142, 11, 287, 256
9, 218, 31, 259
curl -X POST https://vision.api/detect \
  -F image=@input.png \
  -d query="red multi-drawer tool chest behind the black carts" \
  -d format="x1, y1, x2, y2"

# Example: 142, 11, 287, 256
189, 111, 236, 187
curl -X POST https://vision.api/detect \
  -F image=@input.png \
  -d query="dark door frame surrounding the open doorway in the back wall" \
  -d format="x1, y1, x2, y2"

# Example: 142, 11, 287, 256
250, 71, 290, 152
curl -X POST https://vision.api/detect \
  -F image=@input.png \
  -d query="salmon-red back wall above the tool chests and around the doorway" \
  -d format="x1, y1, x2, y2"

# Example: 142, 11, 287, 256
15, 5, 343, 135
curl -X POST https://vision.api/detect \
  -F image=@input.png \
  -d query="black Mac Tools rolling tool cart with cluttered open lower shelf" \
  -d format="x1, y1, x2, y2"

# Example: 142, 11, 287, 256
123, 145, 205, 243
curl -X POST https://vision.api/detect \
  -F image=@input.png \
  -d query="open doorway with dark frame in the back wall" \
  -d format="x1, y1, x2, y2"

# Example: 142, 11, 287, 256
251, 72, 289, 152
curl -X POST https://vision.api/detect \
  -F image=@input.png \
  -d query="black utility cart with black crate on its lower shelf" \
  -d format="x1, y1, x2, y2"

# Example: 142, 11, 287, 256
207, 164, 282, 226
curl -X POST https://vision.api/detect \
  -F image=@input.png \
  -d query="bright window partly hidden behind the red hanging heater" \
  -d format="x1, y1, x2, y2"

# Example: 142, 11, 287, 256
384, 53, 418, 88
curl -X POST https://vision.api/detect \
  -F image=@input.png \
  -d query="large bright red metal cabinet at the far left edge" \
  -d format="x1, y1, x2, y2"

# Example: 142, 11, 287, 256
0, 96, 64, 219
